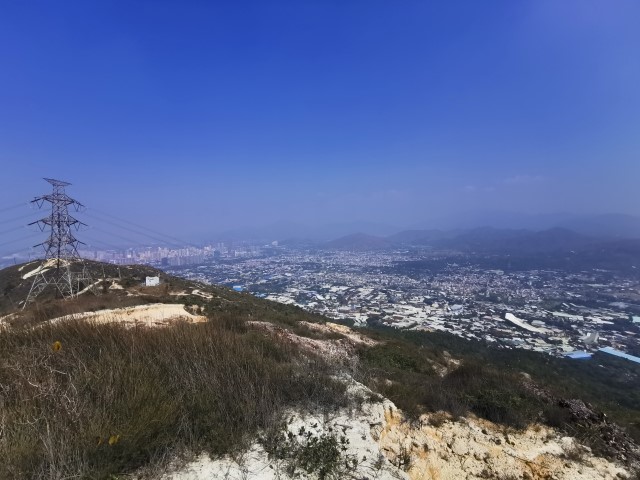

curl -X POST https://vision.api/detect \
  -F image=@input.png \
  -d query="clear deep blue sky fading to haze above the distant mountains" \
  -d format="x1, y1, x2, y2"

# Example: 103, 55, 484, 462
0, 0, 640, 238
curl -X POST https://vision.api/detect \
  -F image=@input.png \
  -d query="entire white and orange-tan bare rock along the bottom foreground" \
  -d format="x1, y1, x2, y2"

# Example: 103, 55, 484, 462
162, 379, 630, 480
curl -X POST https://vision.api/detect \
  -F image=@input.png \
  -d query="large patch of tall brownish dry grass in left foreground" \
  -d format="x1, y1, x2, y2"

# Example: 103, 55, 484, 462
0, 315, 344, 479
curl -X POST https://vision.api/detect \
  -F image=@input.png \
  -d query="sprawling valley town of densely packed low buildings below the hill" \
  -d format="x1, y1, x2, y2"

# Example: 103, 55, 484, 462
165, 248, 640, 355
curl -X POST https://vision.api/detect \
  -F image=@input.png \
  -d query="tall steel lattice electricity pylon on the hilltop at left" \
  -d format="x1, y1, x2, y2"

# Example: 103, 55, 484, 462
24, 178, 93, 307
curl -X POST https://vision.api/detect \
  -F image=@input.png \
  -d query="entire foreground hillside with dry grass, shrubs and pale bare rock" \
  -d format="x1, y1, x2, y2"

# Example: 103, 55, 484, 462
0, 263, 640, 480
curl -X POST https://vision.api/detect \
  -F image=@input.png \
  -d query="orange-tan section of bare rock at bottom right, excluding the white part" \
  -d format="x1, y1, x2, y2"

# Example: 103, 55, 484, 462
374, 404, 629, 480
